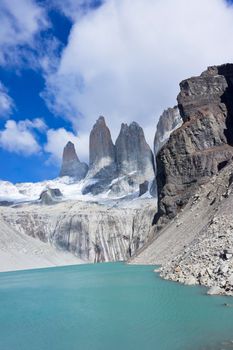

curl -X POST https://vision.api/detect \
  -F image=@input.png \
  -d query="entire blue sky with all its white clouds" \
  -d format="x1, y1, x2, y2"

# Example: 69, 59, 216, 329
0, 0, 233, 183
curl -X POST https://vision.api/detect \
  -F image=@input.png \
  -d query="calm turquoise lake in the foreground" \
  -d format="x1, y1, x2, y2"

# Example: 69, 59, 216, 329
0, 263, 233, 350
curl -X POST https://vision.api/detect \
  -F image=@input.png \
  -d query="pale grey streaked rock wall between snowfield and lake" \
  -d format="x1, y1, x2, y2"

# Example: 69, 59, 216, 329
0, 200, 155, 262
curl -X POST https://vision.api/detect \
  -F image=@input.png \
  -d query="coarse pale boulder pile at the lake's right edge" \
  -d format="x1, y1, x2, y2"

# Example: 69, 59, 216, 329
160, 215, 233, 296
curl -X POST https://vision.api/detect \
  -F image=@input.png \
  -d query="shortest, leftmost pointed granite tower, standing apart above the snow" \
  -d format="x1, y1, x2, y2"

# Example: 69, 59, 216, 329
60, 141, 88, 180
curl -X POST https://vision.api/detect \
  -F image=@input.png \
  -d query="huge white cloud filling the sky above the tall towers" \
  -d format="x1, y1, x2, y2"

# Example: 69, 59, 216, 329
42, 0, 233, 149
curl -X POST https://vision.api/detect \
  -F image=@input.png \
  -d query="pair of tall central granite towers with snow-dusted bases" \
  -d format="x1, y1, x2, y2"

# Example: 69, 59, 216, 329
83, 117, 155, 196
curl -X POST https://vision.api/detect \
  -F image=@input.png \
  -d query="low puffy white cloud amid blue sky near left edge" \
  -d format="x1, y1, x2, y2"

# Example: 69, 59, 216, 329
0, 118, 46, 156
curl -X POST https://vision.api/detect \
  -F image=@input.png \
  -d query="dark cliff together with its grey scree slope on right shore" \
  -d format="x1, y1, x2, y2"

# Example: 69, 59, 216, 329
132, 64, 233, 295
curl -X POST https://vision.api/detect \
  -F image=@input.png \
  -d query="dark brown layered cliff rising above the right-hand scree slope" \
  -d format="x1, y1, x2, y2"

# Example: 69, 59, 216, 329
155, 64, 233, 223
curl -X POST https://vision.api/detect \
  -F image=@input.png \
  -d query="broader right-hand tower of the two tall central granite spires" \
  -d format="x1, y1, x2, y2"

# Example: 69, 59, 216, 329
115, 122, 154, 183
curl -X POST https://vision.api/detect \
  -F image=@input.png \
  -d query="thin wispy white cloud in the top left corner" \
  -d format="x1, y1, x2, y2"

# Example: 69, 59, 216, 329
0, 0, 48, 65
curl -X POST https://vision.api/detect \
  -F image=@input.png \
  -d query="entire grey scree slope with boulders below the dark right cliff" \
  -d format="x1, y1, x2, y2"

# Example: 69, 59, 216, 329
131, 163, 233, 295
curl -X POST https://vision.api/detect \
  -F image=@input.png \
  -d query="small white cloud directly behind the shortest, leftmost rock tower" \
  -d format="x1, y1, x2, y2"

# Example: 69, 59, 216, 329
44, 128, 89, 163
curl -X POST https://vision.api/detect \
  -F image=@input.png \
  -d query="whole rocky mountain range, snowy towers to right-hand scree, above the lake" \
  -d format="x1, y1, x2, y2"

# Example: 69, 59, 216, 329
0, 64, 233, 295
